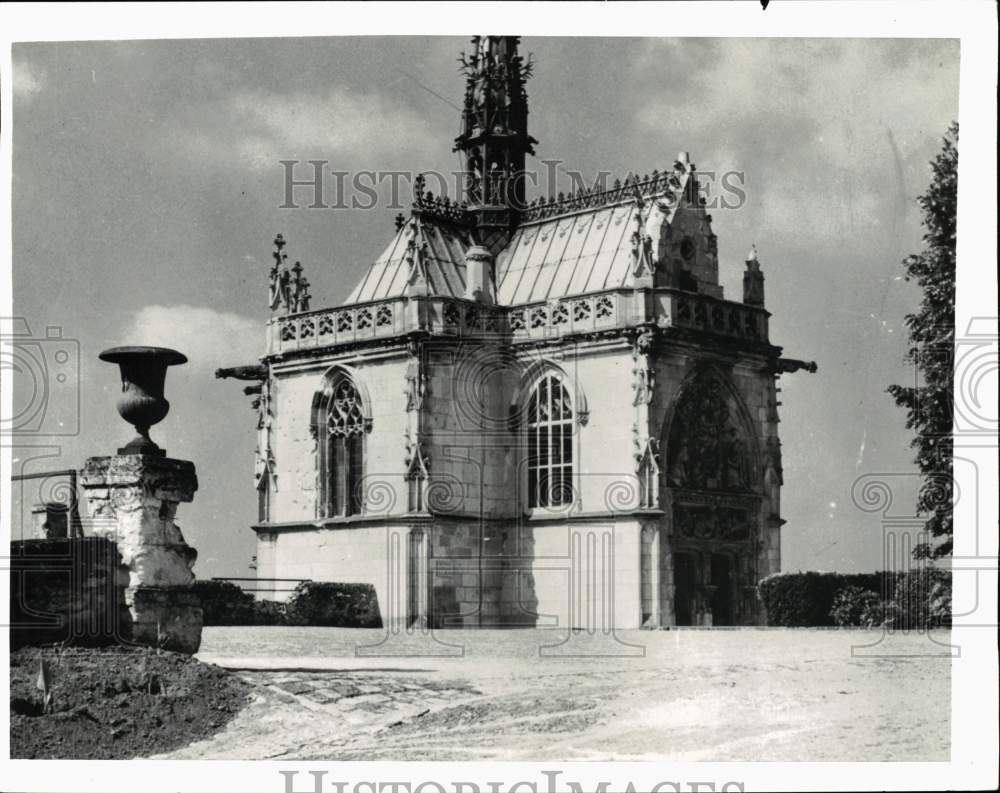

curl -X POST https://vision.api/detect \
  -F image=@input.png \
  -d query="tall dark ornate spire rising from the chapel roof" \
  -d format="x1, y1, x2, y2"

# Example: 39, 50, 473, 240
455, 36, 537, 253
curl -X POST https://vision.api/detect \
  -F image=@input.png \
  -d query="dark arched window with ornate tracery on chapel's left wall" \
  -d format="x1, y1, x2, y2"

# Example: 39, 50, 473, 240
317, 378, 365, 518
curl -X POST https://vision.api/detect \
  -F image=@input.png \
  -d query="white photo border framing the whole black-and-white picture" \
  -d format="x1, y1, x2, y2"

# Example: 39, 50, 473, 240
0, 0, 998, 793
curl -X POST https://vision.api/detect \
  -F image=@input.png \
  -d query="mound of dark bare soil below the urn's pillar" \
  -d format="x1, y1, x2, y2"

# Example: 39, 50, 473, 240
10, 647, 250, 760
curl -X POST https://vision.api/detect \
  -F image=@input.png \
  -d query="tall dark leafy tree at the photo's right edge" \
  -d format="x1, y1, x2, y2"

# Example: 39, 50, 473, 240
888, 123, 958, 559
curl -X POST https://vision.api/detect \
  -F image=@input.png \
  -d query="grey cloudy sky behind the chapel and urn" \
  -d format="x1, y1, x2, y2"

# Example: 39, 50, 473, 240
13, 37, 959, 578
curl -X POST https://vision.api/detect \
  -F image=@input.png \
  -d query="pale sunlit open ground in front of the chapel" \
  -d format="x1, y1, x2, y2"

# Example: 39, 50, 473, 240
156, 627, 952, 761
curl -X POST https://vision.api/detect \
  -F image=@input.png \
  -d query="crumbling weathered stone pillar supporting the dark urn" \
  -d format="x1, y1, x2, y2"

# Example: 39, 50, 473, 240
80, 454, 202, 653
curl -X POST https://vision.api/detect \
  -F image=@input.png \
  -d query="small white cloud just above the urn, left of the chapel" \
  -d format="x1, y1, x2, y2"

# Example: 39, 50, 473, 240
119, 305, 265, 370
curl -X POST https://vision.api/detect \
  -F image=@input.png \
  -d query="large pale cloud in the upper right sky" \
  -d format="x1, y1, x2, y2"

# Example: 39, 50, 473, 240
635, 39, 958, 244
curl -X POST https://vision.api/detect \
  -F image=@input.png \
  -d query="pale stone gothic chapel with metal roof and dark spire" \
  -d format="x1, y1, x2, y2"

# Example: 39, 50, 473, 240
218, 36, 815, 629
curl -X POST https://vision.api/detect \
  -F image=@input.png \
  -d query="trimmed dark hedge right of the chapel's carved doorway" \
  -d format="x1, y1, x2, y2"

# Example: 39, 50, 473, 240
758, 568, 951, 628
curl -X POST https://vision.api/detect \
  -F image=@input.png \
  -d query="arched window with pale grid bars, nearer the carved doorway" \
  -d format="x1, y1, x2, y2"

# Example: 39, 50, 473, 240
528, 374, 573, 508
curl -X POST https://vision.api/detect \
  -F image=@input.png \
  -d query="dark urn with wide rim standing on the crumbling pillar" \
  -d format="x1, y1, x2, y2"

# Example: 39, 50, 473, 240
99, 347, 187, 457
